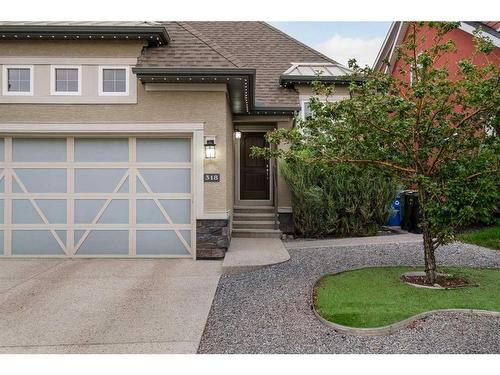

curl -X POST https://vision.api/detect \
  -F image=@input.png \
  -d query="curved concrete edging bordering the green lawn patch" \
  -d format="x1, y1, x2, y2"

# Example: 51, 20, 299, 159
311, 267, 500, 336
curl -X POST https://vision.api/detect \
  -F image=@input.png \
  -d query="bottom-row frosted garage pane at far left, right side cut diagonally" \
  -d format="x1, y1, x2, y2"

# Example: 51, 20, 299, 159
12, 230, 64, 255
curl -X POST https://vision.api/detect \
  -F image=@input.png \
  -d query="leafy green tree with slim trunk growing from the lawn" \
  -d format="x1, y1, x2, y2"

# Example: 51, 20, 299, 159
254, 22, 500, 284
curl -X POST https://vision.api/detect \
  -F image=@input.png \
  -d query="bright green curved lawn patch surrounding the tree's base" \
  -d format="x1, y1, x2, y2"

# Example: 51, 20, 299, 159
314, 267, 500, 328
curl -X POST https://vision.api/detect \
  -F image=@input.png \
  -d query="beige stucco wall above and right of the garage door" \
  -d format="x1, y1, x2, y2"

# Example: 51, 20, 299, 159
0, 84, 233, 212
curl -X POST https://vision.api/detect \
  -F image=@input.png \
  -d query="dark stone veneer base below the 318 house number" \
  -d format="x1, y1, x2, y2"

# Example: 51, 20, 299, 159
196, 220, 231, 259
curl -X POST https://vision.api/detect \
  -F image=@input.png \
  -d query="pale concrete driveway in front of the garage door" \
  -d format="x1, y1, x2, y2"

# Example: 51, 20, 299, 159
0, 259, 221, 353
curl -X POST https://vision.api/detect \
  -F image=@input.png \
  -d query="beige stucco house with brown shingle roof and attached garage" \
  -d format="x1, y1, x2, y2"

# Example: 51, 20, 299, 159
0, 22, 349, 258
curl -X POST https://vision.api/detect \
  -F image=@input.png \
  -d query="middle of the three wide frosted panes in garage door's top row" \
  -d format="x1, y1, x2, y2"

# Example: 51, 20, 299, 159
75, 138, 128, 163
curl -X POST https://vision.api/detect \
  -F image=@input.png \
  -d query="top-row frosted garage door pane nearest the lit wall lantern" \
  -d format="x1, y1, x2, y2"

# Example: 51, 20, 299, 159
136, 138, 191, 163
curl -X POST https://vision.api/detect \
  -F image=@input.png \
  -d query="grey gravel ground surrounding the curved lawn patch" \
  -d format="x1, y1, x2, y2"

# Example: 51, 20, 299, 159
198, 243, 500, 353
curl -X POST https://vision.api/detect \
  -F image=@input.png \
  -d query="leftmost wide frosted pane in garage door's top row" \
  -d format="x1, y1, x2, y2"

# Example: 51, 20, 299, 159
12, 138, 67, 162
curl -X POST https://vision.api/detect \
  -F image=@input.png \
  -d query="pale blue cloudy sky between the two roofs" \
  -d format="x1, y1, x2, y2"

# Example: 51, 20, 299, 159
270, 22, 391, 66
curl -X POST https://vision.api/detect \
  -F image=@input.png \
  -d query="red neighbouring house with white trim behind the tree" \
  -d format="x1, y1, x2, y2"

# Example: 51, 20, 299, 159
373, 21, 500, 81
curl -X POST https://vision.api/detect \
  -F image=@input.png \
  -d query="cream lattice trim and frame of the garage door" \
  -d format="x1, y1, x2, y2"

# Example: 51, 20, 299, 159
0, 124, 203, 258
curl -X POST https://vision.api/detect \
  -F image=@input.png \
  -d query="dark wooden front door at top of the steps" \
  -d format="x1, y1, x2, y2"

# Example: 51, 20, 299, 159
240, 132, 269, 200
